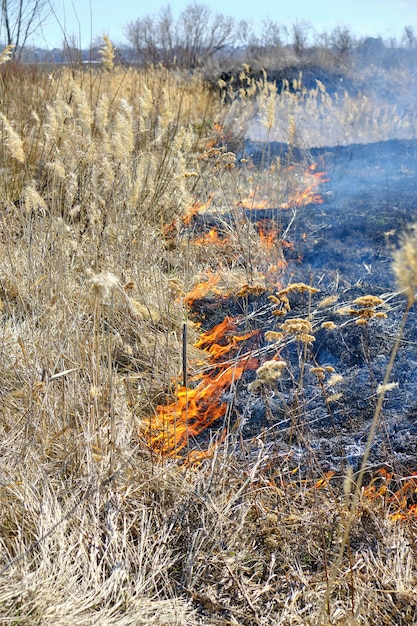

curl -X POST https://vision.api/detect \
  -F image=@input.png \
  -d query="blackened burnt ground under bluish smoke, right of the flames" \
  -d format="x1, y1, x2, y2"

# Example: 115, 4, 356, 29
189, 140, 417, 475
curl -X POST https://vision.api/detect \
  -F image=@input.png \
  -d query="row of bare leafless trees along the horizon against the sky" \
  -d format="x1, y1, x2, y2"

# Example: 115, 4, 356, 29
0, 0, 417, 69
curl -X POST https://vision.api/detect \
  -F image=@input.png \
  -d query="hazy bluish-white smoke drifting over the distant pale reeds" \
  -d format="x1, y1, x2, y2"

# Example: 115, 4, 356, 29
242, 38, 417, 149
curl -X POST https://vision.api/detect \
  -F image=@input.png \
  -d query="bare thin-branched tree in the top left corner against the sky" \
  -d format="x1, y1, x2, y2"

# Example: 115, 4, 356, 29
0, 0, 52, 58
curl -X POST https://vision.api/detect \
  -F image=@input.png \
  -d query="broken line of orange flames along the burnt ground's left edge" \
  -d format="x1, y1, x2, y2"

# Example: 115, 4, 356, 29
143, 160, 325, 462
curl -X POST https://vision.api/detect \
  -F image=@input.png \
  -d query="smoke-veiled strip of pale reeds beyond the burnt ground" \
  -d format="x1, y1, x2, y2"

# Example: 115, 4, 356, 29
235, 67, 417, 149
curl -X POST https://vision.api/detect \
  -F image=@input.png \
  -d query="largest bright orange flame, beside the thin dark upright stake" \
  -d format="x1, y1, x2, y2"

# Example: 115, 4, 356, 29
144, 317, 259, 457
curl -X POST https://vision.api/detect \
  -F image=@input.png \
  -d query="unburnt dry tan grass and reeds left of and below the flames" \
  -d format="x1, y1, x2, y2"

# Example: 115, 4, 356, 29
0, 50, 416, 626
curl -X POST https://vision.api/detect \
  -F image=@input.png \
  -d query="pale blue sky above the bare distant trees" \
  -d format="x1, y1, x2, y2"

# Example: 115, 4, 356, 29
36, 0, 417, 47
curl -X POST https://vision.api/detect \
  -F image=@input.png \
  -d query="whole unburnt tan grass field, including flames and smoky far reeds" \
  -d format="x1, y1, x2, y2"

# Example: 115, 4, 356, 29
0, 42, 417, 626
